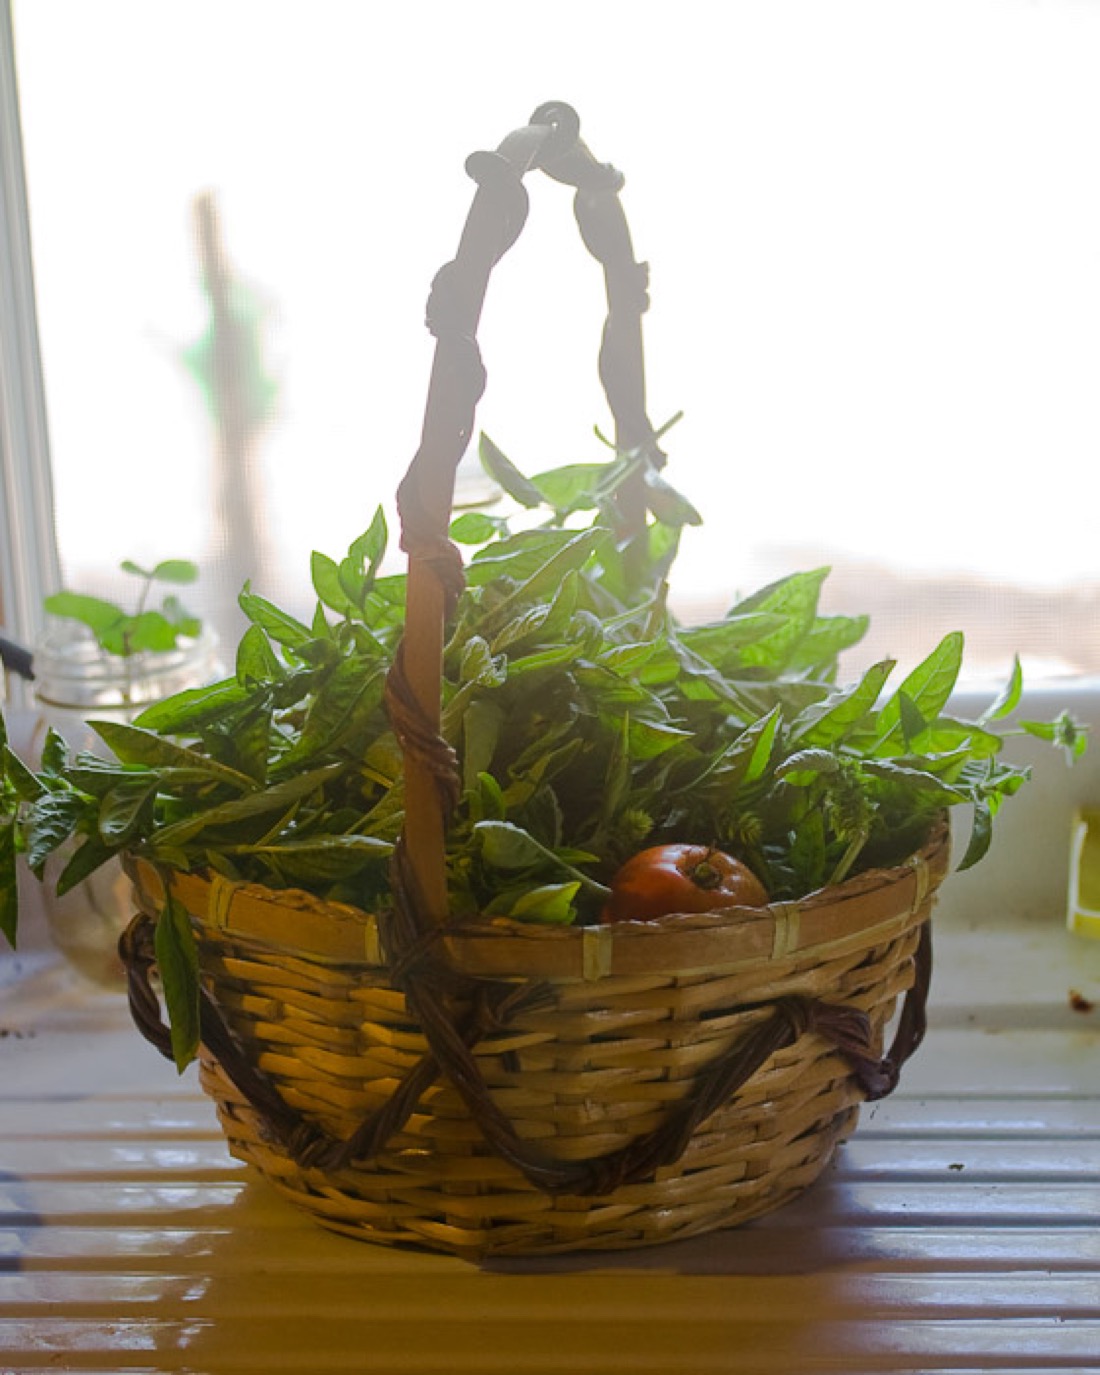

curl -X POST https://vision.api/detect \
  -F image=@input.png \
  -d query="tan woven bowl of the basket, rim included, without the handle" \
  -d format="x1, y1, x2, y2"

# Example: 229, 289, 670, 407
122, 833, 947, 1257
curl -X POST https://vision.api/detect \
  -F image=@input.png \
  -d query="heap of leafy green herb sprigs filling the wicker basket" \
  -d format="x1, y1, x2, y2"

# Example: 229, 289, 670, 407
0, 440, 1085, 1063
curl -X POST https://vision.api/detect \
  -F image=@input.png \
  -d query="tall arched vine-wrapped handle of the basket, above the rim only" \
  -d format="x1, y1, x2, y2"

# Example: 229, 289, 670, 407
386, 102, 666, 928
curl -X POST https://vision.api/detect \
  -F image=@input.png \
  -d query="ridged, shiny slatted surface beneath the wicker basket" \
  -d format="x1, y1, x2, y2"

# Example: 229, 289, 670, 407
0, 925, 1100, 1375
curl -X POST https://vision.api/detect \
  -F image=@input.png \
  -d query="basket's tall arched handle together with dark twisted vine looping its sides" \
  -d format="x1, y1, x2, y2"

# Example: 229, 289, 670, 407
120, 105, 931, 1195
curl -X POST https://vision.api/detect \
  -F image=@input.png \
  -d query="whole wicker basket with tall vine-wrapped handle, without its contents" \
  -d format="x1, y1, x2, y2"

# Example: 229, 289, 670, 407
122, 106, 947, 1258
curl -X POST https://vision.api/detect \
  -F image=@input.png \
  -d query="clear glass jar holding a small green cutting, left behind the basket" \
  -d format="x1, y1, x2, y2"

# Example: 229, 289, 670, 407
32, 623, 223, 987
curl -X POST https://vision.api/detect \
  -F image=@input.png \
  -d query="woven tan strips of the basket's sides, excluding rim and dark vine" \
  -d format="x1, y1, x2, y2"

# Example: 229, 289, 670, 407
138, 814, 946, 1257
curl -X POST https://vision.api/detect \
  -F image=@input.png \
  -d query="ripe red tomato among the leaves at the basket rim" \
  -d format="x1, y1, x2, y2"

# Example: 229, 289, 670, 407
600, 844, 767, 921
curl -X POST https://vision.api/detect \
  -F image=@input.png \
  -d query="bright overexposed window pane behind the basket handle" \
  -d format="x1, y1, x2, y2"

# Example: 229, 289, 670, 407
2, 0, 1100, 677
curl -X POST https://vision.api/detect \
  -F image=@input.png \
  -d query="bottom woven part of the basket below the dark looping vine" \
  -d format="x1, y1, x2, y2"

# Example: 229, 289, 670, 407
201, 1059, 859, 1261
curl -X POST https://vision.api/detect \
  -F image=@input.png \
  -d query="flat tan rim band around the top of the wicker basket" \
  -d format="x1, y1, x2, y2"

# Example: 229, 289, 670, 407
127, 818, 950, 980
